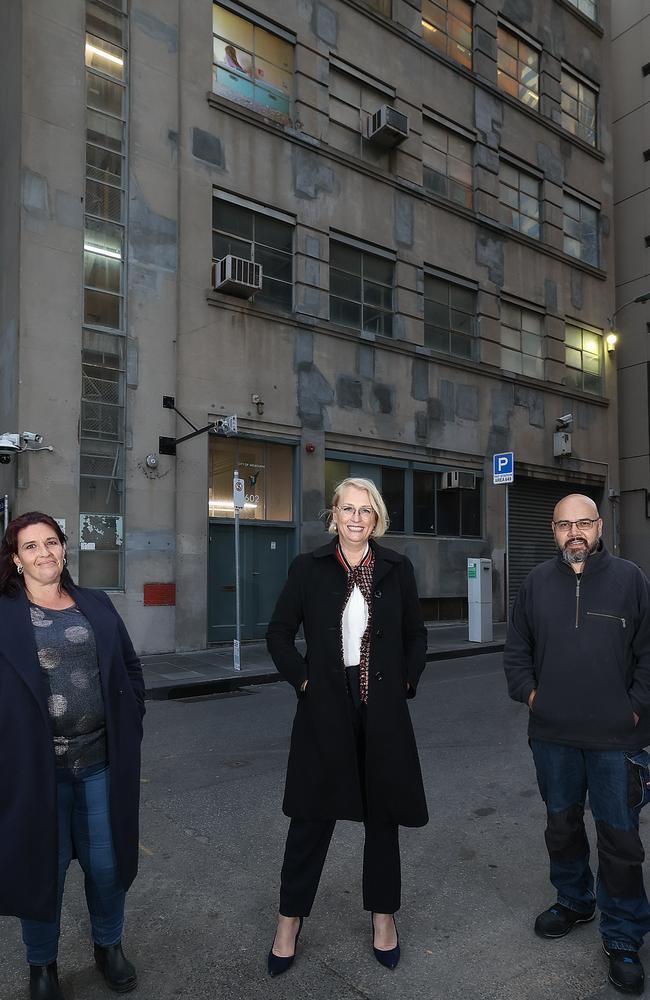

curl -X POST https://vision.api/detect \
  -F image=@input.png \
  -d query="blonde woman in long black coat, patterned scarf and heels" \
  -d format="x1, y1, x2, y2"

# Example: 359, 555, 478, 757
267, 479, 428, 976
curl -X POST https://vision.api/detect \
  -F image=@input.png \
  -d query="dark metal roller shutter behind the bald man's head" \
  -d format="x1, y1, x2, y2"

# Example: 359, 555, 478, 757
508, 478, 603, 606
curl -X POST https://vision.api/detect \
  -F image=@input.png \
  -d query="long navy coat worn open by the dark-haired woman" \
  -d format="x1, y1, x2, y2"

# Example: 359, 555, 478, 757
0, 586, 145, 921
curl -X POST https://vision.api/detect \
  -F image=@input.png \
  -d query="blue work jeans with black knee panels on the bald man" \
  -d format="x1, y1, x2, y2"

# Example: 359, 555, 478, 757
530, 740, 650, 951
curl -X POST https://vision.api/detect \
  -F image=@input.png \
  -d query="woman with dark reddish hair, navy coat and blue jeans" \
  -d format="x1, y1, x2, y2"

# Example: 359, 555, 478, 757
0, 511, 144, 1000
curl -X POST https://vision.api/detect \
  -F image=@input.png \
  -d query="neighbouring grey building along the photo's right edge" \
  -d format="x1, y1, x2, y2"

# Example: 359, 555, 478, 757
612, 0, 650, 574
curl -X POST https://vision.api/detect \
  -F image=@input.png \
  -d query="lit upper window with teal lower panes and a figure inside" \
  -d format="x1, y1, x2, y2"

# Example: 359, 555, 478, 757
212, 4, 293, 125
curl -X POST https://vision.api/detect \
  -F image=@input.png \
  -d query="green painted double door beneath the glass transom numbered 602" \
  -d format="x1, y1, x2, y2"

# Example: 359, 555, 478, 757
208, 523, 295, 642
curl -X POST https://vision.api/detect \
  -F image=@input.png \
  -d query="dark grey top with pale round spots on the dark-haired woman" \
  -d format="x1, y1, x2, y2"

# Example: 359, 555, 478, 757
29, 604, 106, 770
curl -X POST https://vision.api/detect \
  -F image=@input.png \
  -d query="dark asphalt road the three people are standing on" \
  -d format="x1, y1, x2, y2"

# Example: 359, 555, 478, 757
0, 654, 636, 1000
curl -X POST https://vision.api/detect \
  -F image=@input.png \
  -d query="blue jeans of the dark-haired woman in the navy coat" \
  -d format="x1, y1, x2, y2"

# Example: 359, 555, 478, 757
21, 764, 125, 965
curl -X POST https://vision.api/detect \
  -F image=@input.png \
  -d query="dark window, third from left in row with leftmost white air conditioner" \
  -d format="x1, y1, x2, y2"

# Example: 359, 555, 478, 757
424, 274, 478, 361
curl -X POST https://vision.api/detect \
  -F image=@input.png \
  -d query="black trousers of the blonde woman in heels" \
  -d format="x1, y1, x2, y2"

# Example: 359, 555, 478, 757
280, 683, 401, 917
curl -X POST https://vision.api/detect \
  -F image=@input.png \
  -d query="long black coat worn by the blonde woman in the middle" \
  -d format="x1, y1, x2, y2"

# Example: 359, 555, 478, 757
267, 538, 428, 826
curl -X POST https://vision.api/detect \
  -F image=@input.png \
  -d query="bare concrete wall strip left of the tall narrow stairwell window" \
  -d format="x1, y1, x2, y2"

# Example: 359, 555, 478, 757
16, 0, 85, 556
